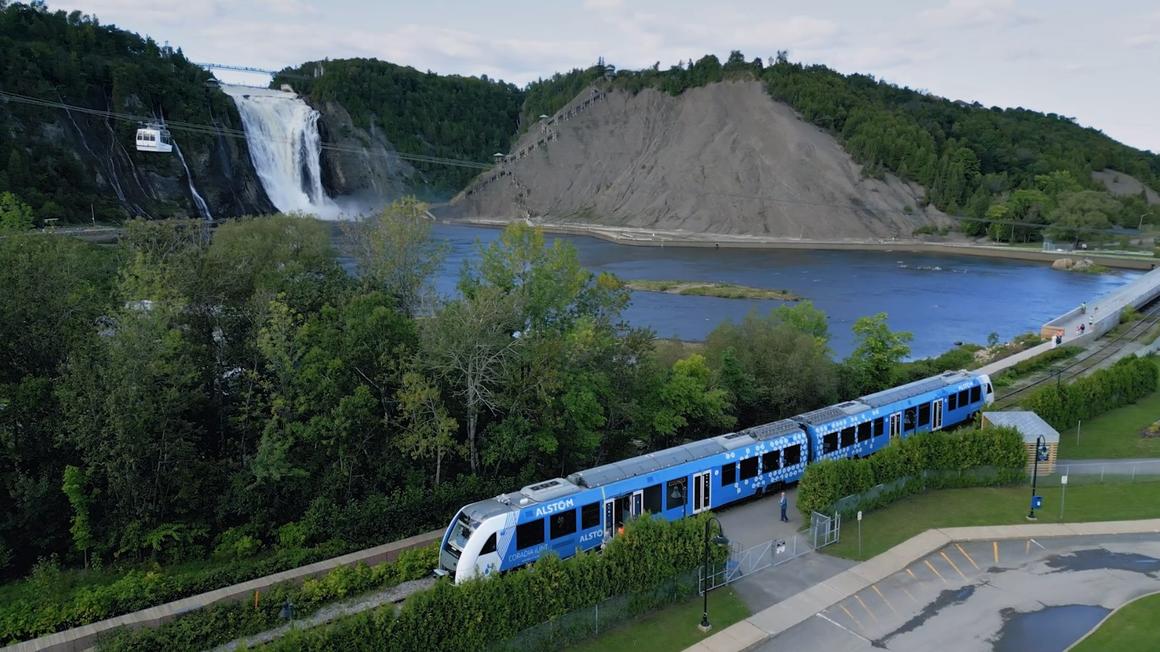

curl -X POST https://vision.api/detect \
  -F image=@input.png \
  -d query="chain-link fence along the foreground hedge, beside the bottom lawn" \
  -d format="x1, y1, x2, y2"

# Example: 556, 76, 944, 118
488, 570, 699, 652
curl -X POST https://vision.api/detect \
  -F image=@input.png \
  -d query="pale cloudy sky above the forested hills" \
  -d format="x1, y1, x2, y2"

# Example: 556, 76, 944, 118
49, 0, 1160, 152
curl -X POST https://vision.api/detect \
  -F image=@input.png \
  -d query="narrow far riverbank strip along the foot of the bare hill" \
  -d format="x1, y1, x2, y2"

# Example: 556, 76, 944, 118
440, 217, 1160, 269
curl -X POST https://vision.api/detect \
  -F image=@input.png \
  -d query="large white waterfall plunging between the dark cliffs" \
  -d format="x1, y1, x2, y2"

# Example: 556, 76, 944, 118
222, 85, 340, 218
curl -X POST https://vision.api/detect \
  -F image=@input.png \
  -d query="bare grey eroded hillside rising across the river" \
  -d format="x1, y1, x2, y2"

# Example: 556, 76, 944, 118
447, 81, 951, 239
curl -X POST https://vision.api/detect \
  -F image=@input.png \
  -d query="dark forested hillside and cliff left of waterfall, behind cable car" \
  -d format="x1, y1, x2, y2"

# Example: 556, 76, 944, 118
0, 0, 268, 222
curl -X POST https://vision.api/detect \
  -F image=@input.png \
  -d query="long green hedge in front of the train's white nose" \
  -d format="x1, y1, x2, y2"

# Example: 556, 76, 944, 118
270, 514, 725, 652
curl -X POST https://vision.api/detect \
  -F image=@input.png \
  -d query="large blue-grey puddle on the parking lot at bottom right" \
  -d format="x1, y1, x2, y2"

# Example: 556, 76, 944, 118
991, 604, 1109, 652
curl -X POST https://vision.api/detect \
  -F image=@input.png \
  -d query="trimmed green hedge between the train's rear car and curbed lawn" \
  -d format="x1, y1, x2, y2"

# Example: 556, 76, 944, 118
797, 428, 1027, 514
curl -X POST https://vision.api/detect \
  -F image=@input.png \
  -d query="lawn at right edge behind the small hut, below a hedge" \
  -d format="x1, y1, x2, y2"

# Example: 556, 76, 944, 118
1059, 359, 1160, 459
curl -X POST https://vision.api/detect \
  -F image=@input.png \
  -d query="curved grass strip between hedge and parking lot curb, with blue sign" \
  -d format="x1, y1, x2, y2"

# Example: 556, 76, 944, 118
824, 479, 1160, 560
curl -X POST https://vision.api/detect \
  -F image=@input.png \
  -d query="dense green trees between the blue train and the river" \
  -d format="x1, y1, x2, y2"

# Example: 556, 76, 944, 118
0, 201, 923, 626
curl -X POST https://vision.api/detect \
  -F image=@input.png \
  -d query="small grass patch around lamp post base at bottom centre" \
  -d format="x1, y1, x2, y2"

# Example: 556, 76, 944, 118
567, 587, 749, 652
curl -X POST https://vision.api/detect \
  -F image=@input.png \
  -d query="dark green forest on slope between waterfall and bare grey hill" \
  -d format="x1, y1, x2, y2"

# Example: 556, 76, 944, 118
274, 59, 523, 195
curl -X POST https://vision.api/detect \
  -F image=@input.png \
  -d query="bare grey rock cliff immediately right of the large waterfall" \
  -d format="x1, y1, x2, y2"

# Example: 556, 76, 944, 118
312, 101, 419, 204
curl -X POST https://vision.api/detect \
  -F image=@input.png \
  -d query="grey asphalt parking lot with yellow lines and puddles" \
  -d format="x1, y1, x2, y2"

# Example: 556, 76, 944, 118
759, 534, 1160, 652
